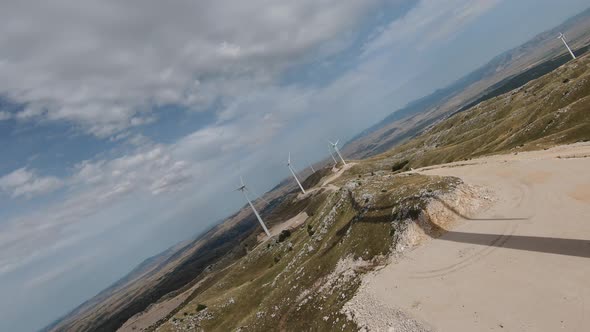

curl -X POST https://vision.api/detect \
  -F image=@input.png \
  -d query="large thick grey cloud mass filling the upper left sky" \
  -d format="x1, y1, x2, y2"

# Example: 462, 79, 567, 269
0, 0, 380, 137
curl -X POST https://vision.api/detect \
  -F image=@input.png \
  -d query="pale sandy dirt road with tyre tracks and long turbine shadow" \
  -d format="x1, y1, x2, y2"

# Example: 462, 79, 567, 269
357, 143, 590, 332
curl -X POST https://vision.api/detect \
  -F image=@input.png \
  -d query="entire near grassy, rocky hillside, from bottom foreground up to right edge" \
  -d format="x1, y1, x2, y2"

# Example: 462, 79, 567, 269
143, 56, 590, 331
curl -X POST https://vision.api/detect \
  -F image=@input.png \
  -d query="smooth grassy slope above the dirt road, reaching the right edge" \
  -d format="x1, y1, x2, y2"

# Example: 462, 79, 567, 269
370, 56, 590, 170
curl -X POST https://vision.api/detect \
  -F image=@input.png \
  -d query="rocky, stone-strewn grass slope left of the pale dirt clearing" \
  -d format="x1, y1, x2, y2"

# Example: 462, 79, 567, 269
161, 174, 456, 331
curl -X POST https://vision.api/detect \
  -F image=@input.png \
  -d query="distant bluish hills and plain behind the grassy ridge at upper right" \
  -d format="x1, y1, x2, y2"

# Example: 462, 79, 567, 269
342, 9, 590, 159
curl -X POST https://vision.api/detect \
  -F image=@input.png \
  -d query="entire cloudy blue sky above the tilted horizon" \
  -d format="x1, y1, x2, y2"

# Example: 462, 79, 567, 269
0, 0, 588, 331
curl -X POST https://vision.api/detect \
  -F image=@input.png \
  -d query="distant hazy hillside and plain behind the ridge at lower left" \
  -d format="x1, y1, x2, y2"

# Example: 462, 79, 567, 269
42, 181, 306, 331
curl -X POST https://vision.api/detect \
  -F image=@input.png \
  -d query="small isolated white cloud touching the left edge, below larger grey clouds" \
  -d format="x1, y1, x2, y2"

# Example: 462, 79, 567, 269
0, 168, 63, 198
